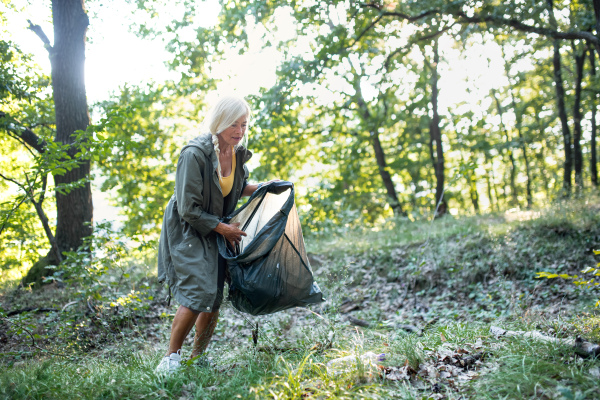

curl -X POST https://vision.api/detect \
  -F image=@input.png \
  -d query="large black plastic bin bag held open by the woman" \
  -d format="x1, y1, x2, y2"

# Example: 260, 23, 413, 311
217, 181, 323, 315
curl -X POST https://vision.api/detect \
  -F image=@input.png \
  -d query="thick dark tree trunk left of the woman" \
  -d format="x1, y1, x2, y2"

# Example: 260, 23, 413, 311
50, 0, 93, 252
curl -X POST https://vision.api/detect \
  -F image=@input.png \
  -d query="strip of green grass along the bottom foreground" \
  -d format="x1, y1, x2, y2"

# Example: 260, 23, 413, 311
0, 314, 600, 399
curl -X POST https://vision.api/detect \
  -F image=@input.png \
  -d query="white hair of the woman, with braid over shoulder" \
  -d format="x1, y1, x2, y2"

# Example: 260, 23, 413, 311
205, 96, 252, 177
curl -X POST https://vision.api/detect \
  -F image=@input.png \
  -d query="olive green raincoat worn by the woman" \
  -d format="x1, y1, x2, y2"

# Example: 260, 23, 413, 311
158, 134, 252, 312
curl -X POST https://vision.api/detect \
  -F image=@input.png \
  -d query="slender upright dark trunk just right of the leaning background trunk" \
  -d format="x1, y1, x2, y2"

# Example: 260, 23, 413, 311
429, 39, 448, 217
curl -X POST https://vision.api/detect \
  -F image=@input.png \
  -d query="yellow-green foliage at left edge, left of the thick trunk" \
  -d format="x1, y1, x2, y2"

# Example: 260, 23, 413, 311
0, 38, 54, 278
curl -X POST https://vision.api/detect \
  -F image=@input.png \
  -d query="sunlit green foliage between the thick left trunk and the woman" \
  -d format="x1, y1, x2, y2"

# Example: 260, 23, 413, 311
92, 87, 184, 240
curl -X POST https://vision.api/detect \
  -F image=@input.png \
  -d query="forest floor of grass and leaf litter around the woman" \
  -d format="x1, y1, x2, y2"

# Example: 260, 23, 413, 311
0, 201, 600, 399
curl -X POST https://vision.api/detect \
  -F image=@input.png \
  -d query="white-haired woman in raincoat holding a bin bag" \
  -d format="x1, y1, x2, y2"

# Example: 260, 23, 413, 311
156, 97, 266, 373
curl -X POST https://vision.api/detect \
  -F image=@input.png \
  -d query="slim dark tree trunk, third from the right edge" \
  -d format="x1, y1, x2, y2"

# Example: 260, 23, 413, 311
547, 0, 573, 197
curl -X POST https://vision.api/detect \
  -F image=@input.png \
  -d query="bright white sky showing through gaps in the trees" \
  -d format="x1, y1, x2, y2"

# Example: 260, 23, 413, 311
5, 0, 505, 111
